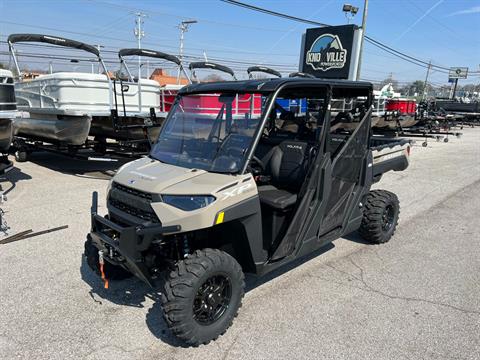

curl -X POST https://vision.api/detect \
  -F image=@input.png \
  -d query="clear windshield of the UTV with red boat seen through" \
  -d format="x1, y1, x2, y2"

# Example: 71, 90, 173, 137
150, 93, 262, 173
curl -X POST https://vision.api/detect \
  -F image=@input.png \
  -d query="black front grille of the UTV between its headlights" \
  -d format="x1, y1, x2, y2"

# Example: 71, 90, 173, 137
108, 183, 160, 223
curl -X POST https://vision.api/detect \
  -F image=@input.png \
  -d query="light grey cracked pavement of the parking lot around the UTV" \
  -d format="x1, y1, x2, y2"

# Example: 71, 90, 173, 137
0, 128, 480, 359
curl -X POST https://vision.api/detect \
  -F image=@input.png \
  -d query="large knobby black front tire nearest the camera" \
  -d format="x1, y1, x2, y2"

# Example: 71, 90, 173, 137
161, 249, 245, 346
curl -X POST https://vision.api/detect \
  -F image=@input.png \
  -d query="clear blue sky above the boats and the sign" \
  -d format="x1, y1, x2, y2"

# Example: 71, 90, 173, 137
0, 0, 480, 86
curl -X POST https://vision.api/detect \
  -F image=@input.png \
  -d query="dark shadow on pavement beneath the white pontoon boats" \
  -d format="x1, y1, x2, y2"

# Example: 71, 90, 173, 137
24, 152, 133, 180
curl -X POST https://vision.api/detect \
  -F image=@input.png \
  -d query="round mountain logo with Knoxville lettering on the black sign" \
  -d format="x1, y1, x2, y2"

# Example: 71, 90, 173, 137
306, 34, 347, 71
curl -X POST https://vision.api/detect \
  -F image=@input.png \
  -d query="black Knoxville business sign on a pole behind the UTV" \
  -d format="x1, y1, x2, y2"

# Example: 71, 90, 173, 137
299, 25, 361, 79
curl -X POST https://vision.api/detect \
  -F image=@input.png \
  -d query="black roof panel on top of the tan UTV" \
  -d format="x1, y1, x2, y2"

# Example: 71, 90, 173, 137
179, 78, 373, 95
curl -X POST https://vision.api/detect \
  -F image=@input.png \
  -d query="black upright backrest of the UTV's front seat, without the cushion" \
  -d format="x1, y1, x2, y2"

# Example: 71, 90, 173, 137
266, 140, 308, 192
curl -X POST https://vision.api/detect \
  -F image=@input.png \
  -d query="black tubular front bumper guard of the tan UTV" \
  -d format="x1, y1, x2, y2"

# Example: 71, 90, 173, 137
89, 192, 181, 287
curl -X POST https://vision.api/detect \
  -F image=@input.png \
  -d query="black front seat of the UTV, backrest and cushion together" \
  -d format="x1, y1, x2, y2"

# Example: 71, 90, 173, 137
258, 140, 308, 211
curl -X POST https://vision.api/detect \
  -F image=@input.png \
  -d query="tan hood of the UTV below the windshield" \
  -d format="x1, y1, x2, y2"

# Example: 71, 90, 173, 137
113, 157, 206, 194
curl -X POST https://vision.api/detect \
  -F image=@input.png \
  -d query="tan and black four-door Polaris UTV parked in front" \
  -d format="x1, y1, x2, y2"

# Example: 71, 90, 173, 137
85, 78, 409, 345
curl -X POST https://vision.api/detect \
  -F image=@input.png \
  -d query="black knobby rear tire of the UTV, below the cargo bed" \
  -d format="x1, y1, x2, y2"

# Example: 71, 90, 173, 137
359, 190, 400, 244
